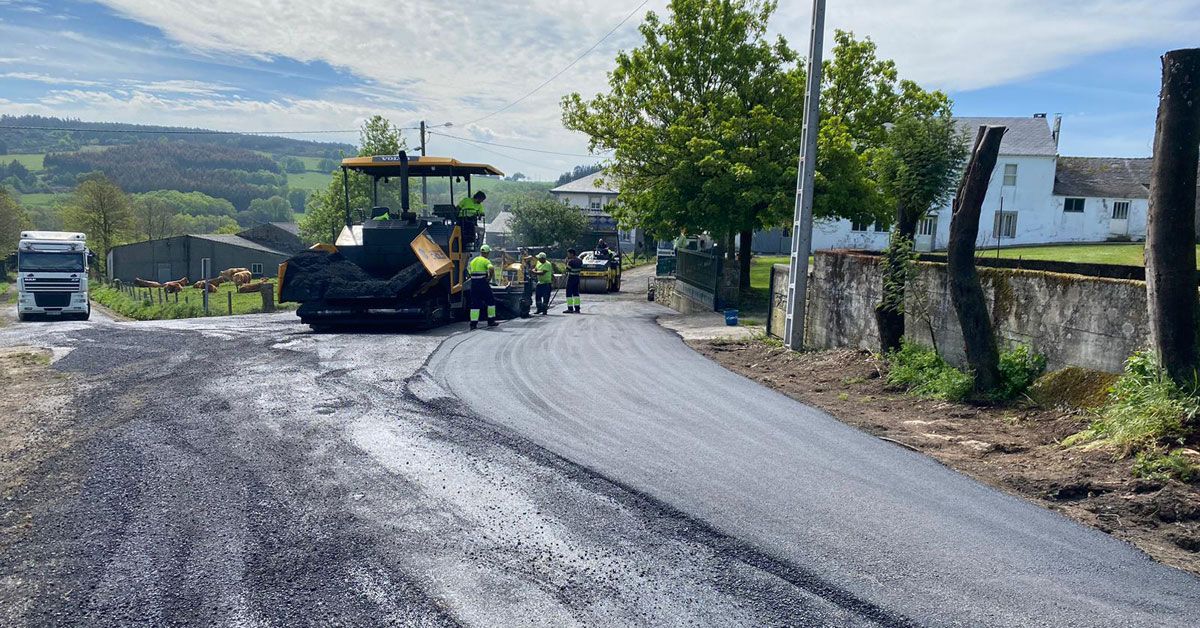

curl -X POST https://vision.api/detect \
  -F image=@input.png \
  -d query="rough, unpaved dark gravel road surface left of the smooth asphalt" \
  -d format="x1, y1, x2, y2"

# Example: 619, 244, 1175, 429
0, 307, 873, 627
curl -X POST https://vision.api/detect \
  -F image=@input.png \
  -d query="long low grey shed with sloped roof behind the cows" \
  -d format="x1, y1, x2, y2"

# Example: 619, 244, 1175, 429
107, 222, 304, 281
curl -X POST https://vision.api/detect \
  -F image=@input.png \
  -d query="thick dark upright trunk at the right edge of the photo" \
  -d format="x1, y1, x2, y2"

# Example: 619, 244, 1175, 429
1146, 48, 1200, 384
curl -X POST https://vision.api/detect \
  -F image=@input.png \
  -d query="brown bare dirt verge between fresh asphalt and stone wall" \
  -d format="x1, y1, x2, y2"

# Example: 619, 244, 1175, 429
689, 340, 1200, 574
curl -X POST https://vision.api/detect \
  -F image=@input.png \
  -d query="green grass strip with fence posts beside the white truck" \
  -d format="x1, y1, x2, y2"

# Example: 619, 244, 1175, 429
91, 283, 295, 321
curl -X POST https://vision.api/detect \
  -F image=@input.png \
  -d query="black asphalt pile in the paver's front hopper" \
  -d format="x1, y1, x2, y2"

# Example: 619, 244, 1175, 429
283, 251, 428, 301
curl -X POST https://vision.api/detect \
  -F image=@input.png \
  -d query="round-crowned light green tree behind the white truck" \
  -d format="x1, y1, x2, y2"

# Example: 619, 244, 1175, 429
62, 174, 134, 271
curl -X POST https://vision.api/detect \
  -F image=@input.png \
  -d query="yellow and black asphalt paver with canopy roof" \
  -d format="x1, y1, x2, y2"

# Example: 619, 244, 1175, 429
278, 151, 533, 329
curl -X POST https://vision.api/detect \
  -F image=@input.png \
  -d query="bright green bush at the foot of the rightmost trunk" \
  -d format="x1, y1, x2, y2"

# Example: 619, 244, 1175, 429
1063, 352, 1200, 456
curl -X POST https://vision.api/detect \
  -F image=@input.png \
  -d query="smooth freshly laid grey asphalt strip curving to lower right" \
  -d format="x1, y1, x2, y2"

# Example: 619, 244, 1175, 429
428, 280, 1200, 626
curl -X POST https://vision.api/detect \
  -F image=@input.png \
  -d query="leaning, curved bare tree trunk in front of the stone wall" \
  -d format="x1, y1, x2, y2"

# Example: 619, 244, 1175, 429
947, 126, 1006, 393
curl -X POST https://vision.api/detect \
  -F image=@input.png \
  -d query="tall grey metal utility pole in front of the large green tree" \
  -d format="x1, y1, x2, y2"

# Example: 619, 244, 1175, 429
784, 0, 824, 351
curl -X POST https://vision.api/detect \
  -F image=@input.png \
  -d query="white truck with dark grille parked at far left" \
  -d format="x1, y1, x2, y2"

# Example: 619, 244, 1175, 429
17, 231, 91, 321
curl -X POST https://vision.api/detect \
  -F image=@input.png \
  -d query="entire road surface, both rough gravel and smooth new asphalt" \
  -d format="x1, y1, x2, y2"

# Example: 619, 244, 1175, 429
0, 277, 1200, 626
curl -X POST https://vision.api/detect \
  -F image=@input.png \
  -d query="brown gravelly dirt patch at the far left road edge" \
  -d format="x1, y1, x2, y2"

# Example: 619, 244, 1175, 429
0, 347, 74, 550
